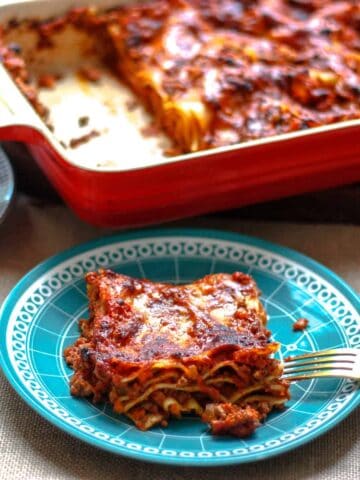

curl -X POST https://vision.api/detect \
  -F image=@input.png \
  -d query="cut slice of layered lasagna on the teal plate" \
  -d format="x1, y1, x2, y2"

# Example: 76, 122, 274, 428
65, 270, 289, 437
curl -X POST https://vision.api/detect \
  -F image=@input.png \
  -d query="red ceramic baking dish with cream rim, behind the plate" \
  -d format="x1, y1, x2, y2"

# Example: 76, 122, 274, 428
0, 0, 360, 227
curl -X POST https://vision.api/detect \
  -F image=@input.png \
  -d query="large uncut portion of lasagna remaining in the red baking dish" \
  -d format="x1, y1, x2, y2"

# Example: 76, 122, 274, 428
0, 0, 360, 153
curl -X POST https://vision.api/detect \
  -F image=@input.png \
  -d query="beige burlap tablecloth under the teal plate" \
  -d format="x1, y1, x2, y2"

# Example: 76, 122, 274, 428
0, 197, 360, 480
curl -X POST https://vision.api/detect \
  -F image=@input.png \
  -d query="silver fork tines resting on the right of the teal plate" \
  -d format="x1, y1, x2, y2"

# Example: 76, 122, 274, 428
283, 348, 360, 381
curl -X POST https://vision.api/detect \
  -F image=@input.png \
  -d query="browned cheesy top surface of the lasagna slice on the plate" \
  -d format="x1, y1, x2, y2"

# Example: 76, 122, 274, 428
87, 271, 272, 368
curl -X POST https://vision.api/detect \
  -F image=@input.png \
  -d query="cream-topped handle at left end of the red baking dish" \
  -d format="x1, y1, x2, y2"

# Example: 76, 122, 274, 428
0, 64, 44, 143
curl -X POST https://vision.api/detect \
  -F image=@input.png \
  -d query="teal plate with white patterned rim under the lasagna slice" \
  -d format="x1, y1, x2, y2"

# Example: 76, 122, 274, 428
0, 230, 360, 466
